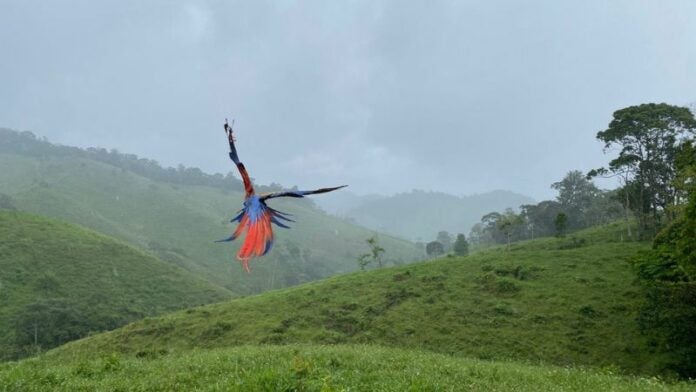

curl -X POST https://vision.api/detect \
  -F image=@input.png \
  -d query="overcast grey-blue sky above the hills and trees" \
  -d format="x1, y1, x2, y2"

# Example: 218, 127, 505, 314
0, 0, 696, 200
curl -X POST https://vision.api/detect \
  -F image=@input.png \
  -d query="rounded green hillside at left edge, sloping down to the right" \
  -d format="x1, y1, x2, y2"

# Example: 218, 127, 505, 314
0, 209, 232, 359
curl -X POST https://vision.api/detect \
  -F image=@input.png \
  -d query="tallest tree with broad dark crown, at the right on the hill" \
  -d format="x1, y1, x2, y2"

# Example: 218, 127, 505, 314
590, 103, 696, 233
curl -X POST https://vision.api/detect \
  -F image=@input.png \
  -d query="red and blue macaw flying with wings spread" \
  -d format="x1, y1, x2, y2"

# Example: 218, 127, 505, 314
216, 120, 347, 272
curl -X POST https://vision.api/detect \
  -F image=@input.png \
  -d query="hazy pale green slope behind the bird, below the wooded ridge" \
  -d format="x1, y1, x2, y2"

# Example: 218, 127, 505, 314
0, 153, 421, 293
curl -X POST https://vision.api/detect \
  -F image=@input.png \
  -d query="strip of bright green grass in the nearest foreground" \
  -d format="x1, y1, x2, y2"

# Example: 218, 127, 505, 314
0, 345, 695, 392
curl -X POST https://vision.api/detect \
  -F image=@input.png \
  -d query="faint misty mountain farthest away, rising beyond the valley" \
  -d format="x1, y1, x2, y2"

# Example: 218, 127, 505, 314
319, 190, 534, 241
